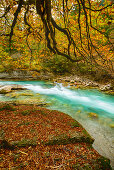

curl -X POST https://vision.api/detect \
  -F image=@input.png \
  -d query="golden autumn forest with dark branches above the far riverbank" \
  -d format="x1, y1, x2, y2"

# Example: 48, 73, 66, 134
0, 0, 114, 79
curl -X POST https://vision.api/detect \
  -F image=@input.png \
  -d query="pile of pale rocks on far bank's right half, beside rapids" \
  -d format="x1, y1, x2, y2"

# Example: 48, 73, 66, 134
53, 75, 114, 95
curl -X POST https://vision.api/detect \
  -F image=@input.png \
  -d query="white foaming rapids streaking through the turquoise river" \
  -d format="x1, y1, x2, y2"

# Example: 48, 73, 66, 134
25, 84, 114, 115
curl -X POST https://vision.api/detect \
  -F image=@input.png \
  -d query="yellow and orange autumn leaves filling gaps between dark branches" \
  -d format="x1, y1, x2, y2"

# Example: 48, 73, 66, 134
0, 0, 113, 74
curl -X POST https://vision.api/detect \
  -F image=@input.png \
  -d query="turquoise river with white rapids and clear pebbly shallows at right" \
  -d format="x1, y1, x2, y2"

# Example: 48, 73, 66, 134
0, 81, 114, 167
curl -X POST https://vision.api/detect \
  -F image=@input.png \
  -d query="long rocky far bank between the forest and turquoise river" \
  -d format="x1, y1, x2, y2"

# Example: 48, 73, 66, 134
0, 71, 114, 95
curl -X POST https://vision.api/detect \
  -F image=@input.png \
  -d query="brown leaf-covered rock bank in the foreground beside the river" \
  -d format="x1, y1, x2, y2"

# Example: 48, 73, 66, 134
0, 104, 111, 170
